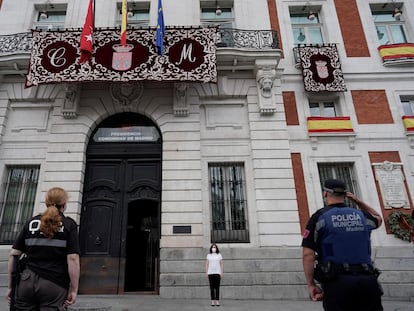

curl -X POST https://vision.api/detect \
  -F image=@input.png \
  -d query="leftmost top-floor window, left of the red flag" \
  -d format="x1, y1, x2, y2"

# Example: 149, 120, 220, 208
33, 3, 66, 31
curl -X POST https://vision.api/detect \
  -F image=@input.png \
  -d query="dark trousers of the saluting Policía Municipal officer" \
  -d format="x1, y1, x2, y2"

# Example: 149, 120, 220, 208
322, 274, 384, 311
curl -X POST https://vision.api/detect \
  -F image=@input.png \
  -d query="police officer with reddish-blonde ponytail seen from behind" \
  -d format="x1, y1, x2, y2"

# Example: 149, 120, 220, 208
7, 187, 80, 311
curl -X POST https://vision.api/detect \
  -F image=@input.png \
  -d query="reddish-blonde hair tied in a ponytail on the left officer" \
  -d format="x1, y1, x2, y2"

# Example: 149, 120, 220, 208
40, 187, 68, 239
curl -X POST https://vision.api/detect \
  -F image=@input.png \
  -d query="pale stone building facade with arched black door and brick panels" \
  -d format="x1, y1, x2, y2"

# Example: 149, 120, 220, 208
0, 0, 414, 300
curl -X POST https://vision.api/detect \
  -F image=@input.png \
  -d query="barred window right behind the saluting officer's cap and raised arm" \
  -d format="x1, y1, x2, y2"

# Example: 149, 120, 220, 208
318, 162, 358, 207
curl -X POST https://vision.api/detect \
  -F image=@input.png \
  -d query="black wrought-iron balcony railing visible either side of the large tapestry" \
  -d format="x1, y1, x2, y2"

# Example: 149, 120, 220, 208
0, 28, 279, 56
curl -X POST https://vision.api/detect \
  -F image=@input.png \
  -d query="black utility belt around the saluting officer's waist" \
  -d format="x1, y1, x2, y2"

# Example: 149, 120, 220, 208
314, 261, 381, 283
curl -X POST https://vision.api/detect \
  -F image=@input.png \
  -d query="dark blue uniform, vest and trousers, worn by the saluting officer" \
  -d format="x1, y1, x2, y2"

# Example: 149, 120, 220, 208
302, 203, 383, 311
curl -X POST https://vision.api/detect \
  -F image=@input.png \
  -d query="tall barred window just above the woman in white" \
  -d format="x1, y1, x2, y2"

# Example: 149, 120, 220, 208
208, 163, 249, 243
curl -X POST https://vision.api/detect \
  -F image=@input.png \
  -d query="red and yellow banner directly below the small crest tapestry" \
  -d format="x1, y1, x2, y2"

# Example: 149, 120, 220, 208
308, 117, 354, 133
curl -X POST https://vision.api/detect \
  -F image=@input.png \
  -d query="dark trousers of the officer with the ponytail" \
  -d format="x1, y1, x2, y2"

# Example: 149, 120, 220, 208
15, 269, 68, 311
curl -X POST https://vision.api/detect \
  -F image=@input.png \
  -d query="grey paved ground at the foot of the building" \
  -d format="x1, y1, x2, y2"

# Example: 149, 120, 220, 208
64, 295, 414, 311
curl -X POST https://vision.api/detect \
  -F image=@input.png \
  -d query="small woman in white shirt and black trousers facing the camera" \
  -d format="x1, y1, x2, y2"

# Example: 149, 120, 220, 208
206, 244, 223, 307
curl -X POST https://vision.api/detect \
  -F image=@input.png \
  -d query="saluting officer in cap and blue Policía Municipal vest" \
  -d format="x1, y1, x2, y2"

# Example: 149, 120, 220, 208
302, 179, 383, 311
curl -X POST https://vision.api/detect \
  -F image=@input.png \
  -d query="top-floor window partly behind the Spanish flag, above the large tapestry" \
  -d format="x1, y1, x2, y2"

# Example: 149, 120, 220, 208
116, 2, 150, 28
